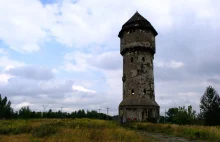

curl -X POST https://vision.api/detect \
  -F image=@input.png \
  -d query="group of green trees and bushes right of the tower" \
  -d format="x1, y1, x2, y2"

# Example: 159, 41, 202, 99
160, 86, 220, 126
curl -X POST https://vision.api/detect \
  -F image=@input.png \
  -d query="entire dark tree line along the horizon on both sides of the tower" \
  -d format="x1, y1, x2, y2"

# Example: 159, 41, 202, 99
0, 86, 220, 126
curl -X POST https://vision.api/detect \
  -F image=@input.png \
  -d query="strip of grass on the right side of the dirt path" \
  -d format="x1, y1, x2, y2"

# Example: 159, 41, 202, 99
127, 123, 220, 142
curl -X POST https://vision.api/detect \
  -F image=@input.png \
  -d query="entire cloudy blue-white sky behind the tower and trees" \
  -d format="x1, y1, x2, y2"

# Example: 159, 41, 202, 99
0, 0, 220, 115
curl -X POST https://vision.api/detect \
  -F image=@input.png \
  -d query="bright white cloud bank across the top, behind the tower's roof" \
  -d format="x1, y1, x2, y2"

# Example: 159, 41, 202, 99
0, 0, 217, 52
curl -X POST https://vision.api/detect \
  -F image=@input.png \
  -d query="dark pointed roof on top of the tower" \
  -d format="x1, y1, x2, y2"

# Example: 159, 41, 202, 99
118, 12, 158, 37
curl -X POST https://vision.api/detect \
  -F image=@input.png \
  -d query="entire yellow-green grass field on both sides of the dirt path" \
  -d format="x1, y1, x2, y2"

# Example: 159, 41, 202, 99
0, 119, 220, 142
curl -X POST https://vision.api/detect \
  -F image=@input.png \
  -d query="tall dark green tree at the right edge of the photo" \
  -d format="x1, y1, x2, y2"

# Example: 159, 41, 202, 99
199, 86, 220, 126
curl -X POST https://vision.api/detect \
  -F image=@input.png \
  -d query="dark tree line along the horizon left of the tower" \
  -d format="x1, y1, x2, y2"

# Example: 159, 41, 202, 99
0, 94, 113, 120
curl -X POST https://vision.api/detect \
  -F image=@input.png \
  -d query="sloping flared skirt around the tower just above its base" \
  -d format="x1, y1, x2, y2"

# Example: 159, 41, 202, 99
120, 97, 159, 106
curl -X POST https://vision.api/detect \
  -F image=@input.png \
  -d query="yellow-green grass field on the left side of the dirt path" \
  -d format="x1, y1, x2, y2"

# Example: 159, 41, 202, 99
0, 119, 155, 142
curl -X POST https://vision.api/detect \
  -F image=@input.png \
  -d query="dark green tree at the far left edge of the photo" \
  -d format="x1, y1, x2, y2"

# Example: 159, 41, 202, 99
0, 94, 13, 119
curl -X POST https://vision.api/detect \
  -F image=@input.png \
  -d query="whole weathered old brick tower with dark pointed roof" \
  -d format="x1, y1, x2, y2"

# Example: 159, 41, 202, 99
119, 12, 159, 121
